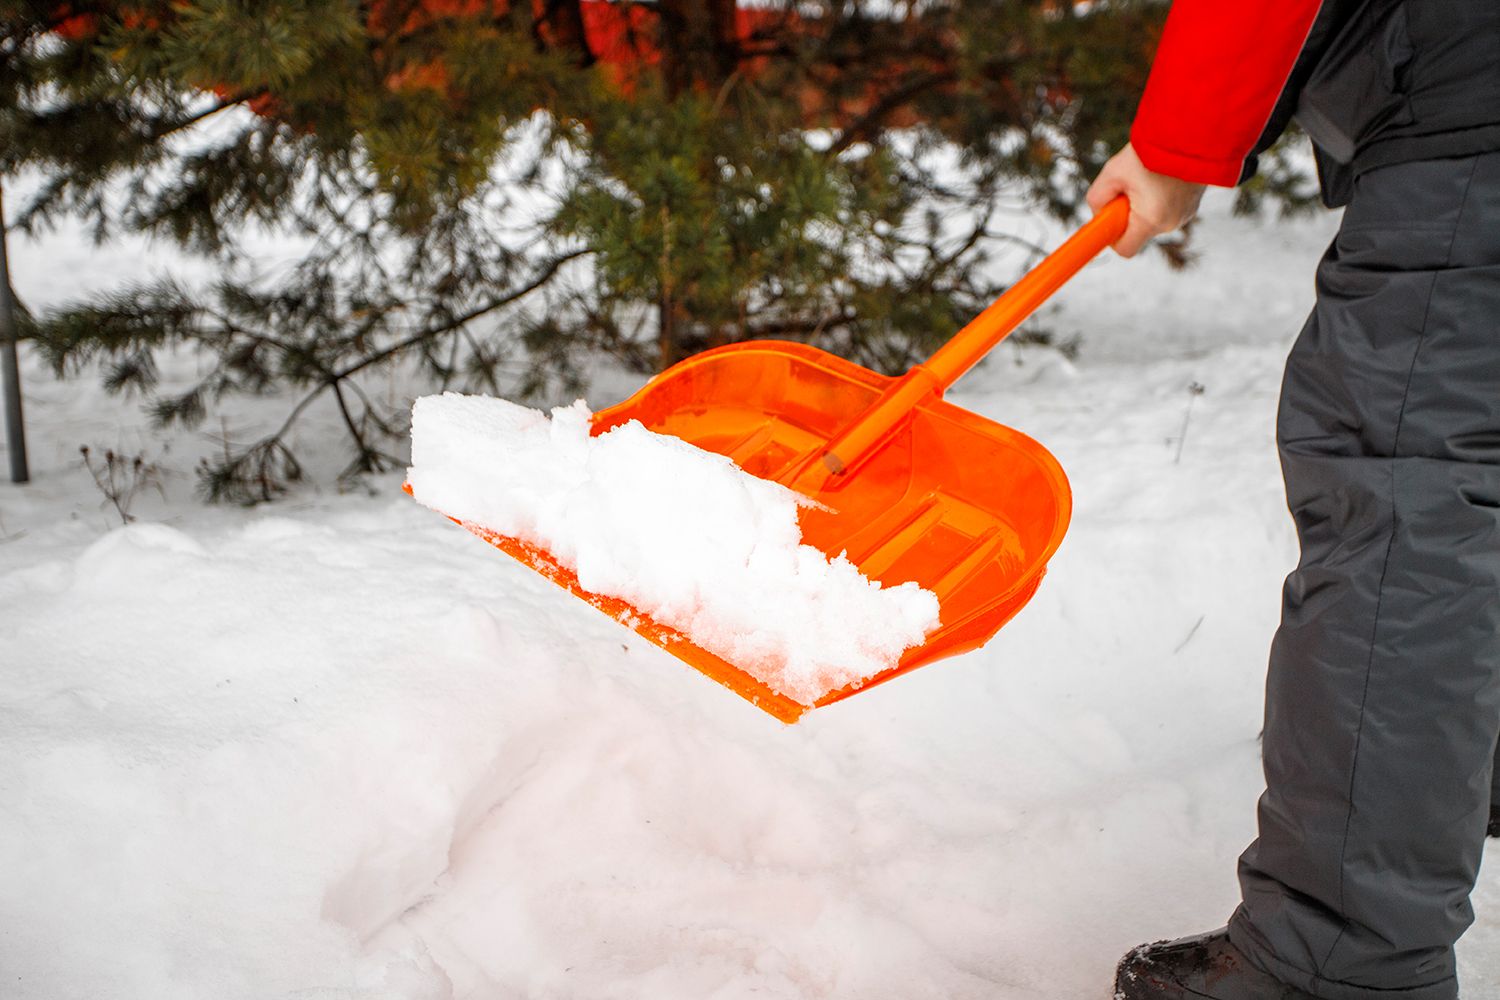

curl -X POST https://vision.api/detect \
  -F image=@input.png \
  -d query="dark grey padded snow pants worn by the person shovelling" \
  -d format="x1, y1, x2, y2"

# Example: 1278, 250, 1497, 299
1230, 153, 1500, 1000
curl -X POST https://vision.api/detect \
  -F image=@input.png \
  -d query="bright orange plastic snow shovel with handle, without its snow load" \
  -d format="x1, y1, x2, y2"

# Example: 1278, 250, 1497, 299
417, 198, 1130, 723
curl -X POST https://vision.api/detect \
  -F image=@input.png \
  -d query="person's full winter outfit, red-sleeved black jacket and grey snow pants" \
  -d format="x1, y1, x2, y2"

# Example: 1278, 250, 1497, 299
1122, 0, 1500, 1000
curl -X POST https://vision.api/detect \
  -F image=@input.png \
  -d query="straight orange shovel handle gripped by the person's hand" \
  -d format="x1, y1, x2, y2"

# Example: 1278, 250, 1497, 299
822, 196, 1130, 474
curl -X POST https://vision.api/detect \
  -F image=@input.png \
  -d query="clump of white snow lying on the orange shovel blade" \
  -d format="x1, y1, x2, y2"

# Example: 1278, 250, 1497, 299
407, 393, 938, 705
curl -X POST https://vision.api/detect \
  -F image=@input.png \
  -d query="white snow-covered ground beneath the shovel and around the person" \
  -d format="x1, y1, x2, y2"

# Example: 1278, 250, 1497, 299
0, 191, 1500, 1000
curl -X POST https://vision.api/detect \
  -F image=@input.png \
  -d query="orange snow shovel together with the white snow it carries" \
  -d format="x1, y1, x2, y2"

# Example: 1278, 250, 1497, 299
407, 198, 1130, 723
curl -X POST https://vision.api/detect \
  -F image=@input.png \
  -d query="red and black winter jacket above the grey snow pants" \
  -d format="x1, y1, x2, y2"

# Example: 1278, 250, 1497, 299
1131, 0, 1500, 205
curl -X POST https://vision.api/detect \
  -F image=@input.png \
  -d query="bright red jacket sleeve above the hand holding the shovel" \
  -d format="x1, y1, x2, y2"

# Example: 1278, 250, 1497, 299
1131, 0, 1325, 187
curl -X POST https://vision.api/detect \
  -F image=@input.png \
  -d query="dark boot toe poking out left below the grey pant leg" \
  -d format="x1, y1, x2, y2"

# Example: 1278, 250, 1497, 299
1115, 928, 1314, 1000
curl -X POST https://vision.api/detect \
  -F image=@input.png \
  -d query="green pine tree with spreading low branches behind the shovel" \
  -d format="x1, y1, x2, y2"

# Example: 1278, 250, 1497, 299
0, 0, 1314, 501
